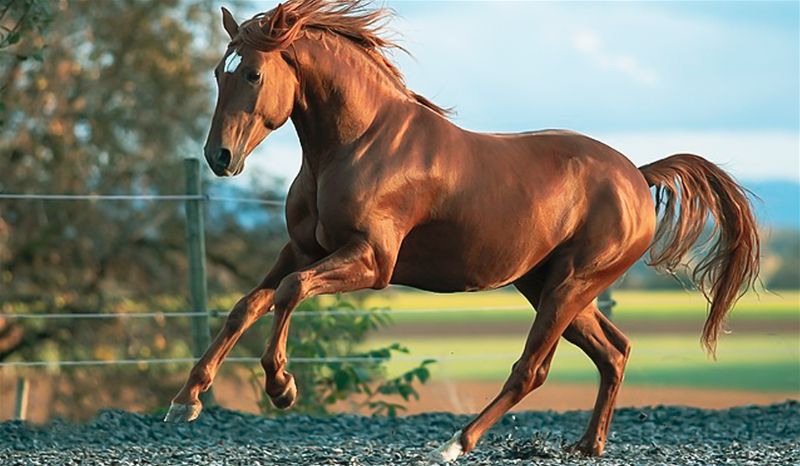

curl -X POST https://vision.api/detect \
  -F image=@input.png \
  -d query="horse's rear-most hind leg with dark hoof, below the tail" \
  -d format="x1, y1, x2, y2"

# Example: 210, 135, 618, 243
564, 303, 630, 456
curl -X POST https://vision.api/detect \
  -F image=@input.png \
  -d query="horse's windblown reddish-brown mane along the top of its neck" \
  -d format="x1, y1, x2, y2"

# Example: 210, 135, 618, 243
232, 0, 450, 116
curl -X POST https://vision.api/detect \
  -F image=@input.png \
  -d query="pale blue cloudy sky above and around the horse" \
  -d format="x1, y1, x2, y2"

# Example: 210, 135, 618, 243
221, 1, 800, 184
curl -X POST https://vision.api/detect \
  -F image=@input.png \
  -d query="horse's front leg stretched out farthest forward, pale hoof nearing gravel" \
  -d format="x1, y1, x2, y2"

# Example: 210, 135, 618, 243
164, 244, 310, 422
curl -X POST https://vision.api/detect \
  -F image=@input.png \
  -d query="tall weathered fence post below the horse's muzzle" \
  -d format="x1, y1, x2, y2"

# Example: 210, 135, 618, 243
184, 158, 214, 405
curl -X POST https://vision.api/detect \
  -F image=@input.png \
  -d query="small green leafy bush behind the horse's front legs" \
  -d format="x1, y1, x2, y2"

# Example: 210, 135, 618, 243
251, 299, 435, 416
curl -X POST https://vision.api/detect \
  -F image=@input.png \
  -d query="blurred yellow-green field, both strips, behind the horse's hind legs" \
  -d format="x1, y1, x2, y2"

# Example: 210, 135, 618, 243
344, 288, 800, 396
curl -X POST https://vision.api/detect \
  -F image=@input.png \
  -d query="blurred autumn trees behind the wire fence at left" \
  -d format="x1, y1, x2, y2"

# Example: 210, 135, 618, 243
0, 0, 283, 416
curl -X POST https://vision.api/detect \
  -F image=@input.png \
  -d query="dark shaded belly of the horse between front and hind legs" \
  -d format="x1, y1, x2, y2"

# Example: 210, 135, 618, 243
392, 223, 549, 292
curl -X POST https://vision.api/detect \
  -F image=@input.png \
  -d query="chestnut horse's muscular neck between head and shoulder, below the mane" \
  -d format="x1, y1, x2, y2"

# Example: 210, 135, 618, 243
289, 33, 413, 162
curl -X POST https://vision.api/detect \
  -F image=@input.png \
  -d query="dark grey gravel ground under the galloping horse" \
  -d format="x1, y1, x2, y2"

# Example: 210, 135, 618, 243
0, 401, 800, 466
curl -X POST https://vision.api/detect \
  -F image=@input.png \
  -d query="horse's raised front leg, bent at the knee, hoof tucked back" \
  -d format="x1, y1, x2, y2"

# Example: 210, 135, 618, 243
261, 239, 394, 409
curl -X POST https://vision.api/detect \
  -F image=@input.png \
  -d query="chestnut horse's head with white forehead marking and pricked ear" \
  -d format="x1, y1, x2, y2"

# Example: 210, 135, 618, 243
205, 8, 298, 176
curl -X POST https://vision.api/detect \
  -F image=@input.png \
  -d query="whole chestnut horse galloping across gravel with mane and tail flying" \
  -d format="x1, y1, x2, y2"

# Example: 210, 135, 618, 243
165, 0, 759, 461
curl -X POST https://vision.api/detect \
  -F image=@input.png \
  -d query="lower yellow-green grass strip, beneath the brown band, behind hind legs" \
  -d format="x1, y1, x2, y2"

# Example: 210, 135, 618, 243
369, 334, 800, 396
